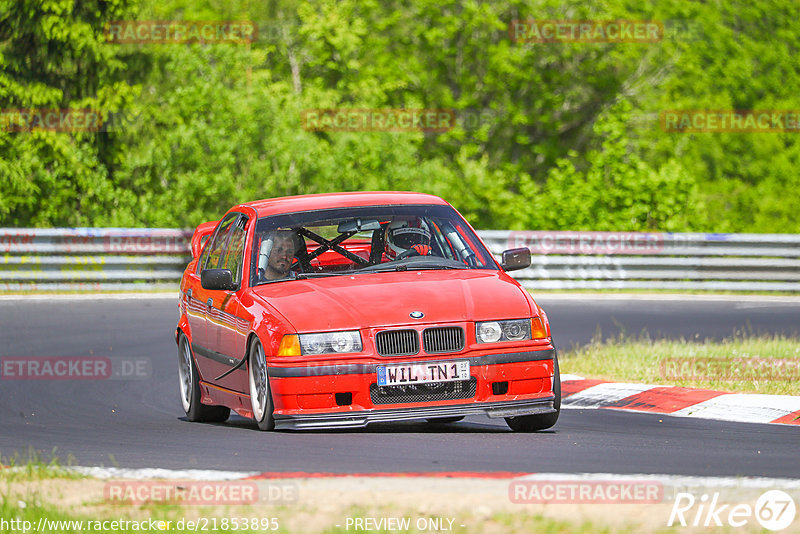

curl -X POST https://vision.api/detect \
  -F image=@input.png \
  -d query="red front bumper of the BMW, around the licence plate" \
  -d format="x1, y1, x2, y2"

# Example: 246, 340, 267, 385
268, 344, 555, 429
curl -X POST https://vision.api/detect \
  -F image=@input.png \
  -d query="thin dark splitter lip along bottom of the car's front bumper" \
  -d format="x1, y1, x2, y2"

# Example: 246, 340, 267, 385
275, 395, 556, 430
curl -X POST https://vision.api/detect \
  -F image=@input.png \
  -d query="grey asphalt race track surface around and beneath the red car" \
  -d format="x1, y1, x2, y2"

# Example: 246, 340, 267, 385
0, 295, 800, 478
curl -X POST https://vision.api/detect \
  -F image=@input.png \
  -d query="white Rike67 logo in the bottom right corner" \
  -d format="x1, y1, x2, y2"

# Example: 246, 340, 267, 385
667, 490, 797, 532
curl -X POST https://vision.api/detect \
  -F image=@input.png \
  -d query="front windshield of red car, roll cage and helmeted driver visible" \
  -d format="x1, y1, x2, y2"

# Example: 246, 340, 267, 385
250, 205, 497, 285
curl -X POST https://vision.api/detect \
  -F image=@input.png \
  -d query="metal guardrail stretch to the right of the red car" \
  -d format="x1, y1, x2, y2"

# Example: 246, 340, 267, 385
480, 231, 800, 291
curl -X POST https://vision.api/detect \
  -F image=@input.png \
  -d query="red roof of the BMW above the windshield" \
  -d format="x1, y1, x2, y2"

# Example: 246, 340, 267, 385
237, 191, 448, 217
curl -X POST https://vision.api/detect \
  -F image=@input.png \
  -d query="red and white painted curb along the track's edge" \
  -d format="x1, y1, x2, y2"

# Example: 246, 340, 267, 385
561, 375, 800, 425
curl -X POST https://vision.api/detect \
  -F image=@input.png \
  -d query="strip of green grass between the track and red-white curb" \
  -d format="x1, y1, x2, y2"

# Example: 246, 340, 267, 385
559, 335, 800, 395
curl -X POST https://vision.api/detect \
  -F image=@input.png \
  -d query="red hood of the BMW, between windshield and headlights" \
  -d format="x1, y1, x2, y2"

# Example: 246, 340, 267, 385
253, 270, 532, 332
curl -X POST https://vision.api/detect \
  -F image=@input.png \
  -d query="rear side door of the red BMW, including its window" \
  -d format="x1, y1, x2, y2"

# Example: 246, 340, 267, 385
188, 213, 240, 388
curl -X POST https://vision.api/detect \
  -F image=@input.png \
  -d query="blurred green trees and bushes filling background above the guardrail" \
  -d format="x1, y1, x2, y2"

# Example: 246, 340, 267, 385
0, 0, 800, 233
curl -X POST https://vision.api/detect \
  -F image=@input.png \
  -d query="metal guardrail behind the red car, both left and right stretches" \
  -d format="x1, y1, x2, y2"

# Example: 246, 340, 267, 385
0, 228, 800, 292
